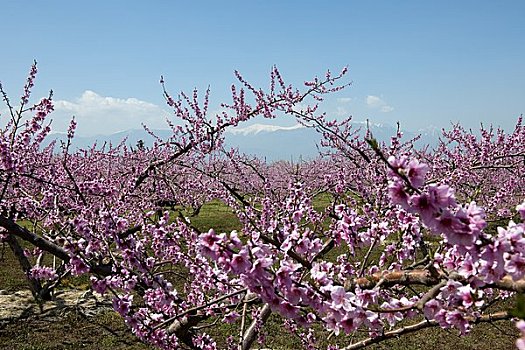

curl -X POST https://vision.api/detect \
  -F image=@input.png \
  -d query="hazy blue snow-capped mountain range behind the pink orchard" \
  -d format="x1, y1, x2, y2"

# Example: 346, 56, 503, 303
48, 123, 438, 161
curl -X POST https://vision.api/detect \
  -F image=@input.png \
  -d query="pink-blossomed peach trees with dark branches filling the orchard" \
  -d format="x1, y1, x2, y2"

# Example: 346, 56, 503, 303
0, 63, 525, 349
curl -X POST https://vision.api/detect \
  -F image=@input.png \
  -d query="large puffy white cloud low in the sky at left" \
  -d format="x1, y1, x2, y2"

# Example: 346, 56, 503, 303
50, 90, 170, 135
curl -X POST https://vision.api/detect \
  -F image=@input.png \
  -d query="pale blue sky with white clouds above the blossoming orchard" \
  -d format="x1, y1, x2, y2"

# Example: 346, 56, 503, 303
0, 0, 525, 134
